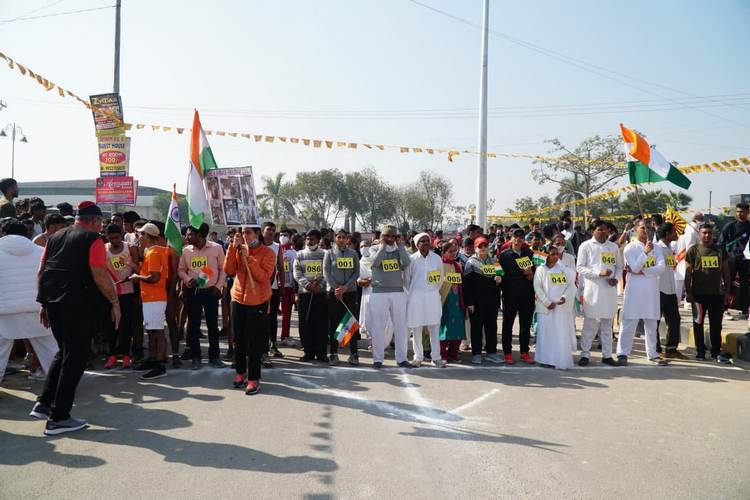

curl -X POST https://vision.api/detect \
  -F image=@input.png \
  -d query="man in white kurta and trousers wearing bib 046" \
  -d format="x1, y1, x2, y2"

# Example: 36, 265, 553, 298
576, 220, 622, 366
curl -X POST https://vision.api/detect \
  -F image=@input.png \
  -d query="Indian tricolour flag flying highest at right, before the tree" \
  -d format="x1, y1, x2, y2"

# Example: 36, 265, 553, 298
620, 123, 690, 189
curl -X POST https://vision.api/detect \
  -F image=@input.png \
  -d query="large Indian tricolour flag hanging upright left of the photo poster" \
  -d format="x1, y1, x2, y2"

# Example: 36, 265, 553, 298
187, 110, 218, 228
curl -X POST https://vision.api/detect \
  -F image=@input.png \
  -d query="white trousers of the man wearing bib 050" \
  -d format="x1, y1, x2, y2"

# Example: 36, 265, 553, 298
367, 292, 408, 363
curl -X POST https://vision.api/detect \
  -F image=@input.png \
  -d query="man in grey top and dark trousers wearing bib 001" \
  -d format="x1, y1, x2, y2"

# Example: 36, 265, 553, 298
323, 229, 359, 366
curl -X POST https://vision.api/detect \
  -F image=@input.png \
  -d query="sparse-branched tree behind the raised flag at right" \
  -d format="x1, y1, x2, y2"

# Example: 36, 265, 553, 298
532, 135, 627, 225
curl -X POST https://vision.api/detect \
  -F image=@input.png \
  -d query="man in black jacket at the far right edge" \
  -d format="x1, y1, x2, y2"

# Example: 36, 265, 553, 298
719, 203, 750, 319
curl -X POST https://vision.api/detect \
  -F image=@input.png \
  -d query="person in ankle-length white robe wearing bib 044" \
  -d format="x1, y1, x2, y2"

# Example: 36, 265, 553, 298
534, 247, 576, 370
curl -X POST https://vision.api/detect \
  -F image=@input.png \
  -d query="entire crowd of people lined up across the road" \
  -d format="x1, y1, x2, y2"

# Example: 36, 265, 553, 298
0, 175, 750, 434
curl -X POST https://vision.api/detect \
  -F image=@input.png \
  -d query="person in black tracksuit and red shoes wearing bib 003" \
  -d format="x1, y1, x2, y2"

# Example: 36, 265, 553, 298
500, 229, 535, 365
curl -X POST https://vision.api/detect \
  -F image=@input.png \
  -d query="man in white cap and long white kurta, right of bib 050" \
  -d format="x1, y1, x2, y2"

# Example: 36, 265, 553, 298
406, 233, 445, 368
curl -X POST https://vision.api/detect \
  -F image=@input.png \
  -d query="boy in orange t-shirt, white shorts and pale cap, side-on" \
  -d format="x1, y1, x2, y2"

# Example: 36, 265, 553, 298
130, 223, 169, 380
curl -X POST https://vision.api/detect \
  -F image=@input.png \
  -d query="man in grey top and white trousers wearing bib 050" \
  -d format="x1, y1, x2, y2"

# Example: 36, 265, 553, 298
367, 225, 412, 368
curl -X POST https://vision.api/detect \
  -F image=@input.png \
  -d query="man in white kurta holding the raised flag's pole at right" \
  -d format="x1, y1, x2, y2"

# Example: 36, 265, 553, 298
617, 220, 666, 366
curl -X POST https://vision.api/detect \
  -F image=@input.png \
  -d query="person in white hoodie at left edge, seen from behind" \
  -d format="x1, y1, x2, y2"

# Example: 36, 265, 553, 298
0, 219, 58, 380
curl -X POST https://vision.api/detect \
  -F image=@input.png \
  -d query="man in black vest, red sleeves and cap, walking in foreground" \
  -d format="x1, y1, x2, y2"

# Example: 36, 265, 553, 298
31, 201, 120, 436
